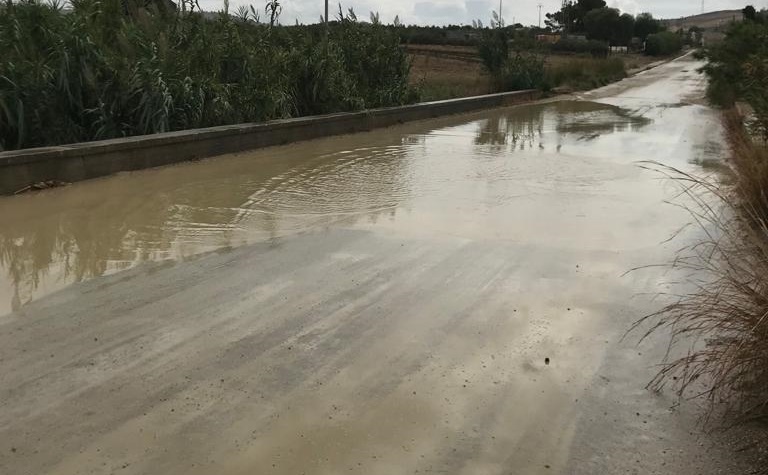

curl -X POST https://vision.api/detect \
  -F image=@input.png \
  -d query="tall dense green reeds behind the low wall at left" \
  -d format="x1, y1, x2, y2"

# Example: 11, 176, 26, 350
0, 0, 416, 150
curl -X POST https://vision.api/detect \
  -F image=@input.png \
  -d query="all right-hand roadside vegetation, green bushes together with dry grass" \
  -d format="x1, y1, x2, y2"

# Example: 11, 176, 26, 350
638, 7, 768, 424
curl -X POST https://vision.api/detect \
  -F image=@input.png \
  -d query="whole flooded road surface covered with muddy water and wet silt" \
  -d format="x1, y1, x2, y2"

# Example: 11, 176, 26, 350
0, 59, 756, 475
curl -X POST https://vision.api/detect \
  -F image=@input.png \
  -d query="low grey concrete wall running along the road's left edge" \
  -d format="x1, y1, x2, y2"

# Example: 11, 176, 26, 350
0, 91, 540, 195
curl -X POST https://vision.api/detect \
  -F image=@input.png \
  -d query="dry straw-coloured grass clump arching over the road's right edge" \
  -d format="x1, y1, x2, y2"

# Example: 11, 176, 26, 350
634, 113, 768, 423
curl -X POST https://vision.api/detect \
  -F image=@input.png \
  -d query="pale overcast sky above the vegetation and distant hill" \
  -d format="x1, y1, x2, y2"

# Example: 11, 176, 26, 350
199, 0, 768, 25
